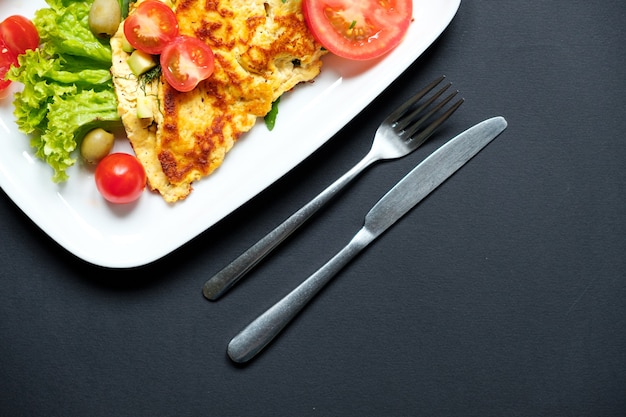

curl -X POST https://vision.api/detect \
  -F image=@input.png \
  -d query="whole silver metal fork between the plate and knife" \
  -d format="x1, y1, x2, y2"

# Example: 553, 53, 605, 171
202, 76, 463, 300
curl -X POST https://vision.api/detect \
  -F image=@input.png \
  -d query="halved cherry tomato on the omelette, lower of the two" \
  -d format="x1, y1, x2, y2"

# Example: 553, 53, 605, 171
161, 36, 215, 92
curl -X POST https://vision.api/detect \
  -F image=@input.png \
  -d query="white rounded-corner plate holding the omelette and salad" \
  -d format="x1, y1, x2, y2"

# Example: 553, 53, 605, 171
0, 0, 460, 268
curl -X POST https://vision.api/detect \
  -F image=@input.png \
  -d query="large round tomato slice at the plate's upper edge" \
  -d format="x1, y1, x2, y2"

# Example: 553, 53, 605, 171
302, 0, 413, 60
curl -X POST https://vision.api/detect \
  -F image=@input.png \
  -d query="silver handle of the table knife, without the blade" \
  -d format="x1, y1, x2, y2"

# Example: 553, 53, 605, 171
228, 227, 374, 363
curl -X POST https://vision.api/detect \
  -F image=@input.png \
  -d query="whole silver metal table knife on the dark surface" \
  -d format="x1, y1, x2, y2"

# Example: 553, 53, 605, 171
228, 117, 507, 363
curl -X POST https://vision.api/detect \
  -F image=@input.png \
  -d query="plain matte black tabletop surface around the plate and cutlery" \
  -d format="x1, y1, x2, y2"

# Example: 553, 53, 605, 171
0, 0, 626, 416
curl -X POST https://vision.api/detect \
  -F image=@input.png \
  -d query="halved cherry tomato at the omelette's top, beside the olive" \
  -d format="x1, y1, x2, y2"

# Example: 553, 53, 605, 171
124, 0, 178, 55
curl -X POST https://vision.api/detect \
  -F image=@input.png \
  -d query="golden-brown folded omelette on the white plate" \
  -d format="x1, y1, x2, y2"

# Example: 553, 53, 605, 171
111, 0, 325, 203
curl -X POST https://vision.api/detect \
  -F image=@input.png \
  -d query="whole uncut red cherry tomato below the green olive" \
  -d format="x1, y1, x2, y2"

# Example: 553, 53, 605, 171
95, 152, 146, 204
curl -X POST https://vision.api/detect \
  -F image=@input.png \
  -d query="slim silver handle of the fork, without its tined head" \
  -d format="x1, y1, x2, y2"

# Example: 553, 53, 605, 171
202, 151, 378, 300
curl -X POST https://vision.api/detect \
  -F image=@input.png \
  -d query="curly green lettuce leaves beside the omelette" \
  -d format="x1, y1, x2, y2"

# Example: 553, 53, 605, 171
8, 0, 121, 182
